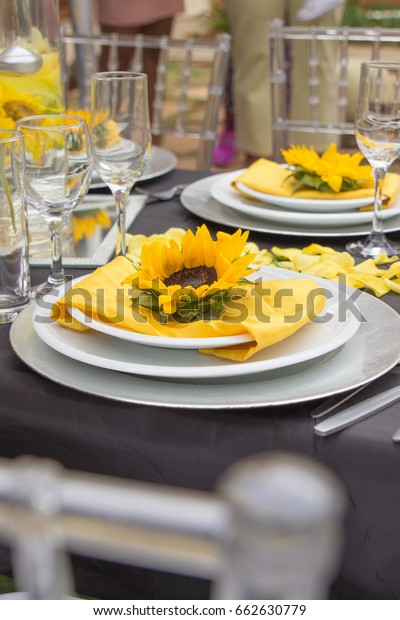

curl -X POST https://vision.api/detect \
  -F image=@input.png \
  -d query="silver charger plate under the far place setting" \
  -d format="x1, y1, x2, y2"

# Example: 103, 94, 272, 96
180, 173, 400, 238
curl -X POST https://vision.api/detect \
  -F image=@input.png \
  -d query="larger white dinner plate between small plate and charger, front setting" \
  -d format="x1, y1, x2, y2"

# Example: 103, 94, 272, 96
33, 267, 359, 380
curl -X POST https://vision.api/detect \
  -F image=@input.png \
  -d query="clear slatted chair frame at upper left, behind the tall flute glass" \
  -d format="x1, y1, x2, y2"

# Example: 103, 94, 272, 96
61, 33, 231, 170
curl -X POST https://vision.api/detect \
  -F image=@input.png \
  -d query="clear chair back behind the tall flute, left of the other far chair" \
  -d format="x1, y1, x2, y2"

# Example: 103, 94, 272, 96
62, 34, 231, 170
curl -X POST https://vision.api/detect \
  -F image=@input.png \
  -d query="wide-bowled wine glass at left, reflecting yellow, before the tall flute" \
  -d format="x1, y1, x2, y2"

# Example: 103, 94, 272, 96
17, 114, 92, 294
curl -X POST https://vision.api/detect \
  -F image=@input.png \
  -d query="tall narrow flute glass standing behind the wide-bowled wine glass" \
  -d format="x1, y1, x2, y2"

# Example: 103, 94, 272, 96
90, 71, 151, 256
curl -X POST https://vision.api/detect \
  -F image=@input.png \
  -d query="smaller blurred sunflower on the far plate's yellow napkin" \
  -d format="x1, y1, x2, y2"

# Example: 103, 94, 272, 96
282, 144, 374, 193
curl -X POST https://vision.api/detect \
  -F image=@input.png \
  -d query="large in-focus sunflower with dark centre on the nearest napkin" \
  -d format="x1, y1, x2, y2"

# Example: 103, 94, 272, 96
123, 225, 255, 323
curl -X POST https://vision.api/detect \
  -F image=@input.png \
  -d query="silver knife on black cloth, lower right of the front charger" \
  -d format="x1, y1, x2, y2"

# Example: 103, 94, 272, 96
314, 386, 400, 437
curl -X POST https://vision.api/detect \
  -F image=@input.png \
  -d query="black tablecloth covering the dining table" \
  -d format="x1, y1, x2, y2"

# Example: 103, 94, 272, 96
0, 169, 400, 600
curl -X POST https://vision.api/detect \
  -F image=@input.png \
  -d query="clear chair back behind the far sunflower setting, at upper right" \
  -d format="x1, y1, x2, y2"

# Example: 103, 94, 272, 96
268, 19, 400, 161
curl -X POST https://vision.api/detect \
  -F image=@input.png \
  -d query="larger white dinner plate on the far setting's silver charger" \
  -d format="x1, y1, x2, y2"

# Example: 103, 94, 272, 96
210, 171, 400, 228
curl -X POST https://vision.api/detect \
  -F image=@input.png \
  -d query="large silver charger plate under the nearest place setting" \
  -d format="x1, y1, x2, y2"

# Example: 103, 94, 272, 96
10, 292, 400, 410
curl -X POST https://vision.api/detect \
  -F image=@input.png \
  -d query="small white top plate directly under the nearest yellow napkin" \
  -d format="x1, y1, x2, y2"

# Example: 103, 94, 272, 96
66, 276, 252, 350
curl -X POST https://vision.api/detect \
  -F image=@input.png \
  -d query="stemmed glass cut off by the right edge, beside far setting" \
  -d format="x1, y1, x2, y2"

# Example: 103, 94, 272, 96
346, 60, 400, 258
